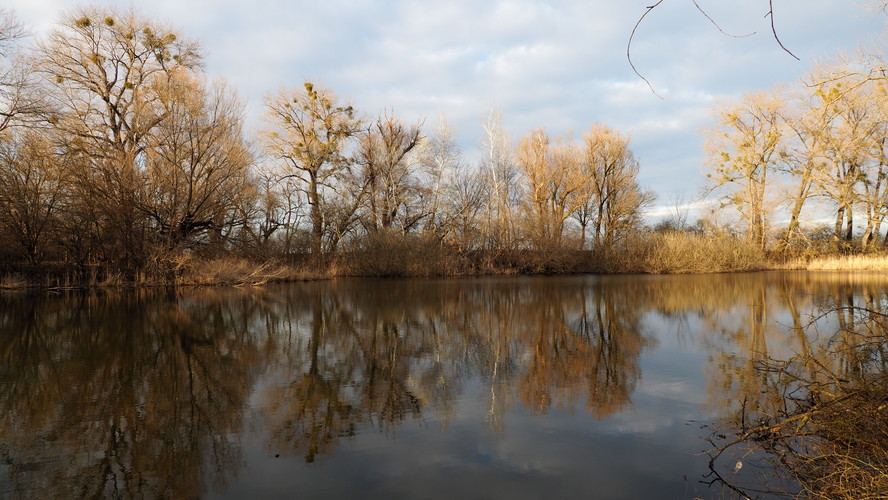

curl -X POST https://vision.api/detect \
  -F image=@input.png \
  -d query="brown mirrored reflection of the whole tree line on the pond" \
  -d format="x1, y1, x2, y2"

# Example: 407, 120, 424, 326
0, 273, 886, 498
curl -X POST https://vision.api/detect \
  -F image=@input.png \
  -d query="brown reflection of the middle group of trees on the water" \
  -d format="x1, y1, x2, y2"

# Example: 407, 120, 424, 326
263, 280, 645, 462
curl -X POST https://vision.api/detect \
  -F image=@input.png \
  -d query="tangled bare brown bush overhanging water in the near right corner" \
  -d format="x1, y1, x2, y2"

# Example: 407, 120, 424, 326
709, 282, 888, 499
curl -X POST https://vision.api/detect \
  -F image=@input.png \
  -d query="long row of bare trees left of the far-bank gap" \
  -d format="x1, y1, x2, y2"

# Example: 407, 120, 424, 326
0, 8, 653, 278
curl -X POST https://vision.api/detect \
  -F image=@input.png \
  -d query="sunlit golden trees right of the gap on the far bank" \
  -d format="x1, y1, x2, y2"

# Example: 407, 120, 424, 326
706, 47, 888, 251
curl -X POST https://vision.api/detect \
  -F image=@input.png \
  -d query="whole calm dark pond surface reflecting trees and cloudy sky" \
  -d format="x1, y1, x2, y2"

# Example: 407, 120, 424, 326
0, 273, 888, 499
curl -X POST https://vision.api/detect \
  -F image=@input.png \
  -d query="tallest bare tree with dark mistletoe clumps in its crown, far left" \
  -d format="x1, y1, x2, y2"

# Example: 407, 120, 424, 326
39, 8, 201, 268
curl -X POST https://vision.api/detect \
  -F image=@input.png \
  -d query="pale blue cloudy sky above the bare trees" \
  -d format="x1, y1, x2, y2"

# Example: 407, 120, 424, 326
4, 0, 886, 215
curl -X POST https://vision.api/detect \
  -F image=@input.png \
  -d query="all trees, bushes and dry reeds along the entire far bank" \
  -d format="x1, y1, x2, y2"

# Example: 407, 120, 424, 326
0, 4, 888, 288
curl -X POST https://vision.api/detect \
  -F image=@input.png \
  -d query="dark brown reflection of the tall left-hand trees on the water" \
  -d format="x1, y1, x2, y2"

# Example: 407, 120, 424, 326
0, 292, 260, 498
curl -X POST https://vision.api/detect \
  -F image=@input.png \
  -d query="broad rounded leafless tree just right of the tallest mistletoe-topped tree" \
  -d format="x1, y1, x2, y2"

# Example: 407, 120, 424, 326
137, 71, 253, 248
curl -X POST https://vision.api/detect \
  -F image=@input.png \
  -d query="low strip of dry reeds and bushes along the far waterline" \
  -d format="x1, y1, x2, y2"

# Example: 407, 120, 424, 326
0, 232, 888, 290
